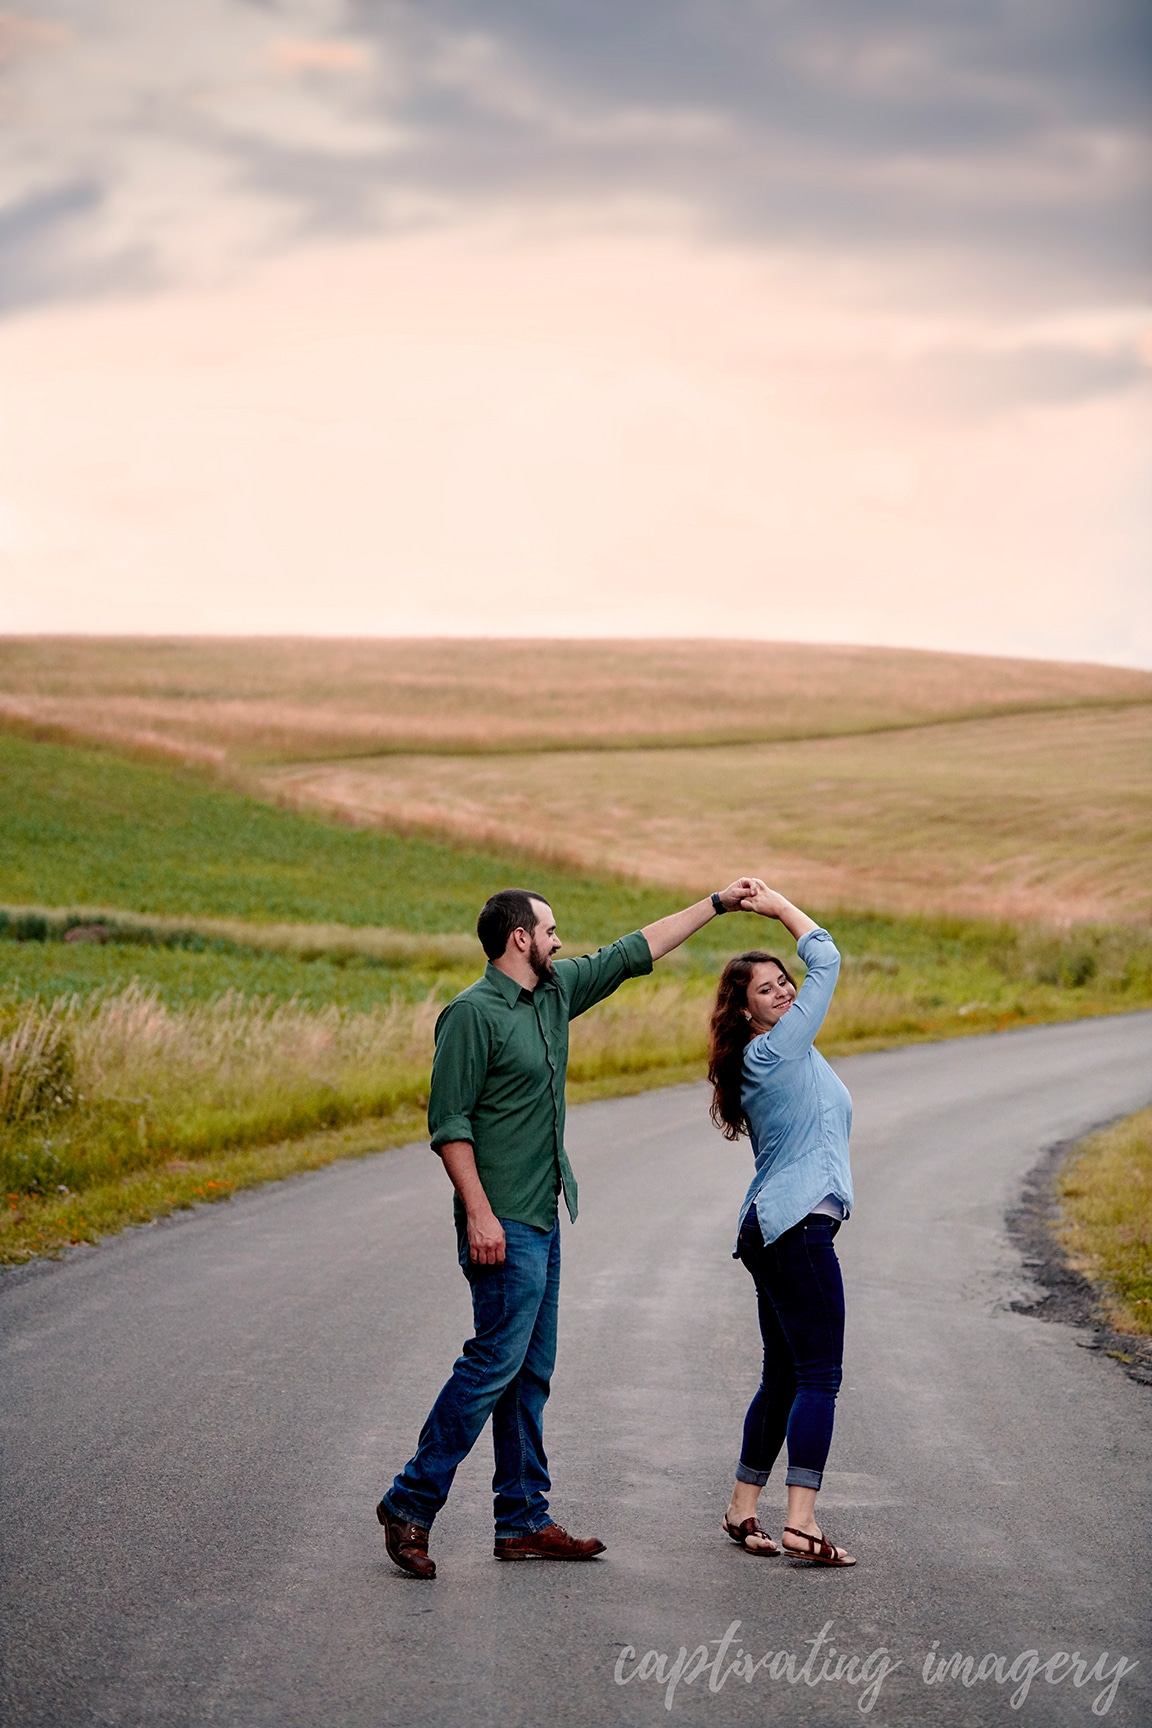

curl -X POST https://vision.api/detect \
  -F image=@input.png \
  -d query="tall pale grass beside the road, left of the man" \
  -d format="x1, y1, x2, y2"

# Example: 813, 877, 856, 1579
0, 983, 439, 1194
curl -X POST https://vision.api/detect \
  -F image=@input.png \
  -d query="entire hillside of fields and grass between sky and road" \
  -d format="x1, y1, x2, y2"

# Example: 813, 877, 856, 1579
0, 641, 1152, 1261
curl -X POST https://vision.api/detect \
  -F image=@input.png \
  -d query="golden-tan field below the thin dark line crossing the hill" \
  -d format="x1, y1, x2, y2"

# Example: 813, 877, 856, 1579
263, 707, 1152, 924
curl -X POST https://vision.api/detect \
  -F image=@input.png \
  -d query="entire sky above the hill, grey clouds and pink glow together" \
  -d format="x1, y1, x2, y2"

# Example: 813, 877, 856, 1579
0, 0, 1152, 665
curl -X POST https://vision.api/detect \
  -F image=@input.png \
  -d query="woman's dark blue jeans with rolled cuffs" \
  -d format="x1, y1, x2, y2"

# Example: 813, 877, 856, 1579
736, 1206, 845, 1488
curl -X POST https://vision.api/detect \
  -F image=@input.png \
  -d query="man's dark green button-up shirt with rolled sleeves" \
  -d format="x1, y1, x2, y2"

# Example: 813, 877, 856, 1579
428, 930, 653, 1230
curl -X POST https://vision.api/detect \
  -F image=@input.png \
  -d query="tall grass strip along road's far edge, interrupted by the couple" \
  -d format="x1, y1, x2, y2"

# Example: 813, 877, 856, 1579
0, 961, 1146, 1216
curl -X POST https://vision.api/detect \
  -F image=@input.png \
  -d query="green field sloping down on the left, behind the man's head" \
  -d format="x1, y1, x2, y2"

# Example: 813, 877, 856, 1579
0, 734, 679, 943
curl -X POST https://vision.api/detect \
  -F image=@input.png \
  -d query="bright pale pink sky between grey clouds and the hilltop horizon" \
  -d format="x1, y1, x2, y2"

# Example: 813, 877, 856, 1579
0, 226, 1152, 665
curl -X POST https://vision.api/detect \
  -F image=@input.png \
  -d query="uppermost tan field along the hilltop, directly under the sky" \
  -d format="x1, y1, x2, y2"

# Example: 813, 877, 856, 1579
0, 638, 1152, 767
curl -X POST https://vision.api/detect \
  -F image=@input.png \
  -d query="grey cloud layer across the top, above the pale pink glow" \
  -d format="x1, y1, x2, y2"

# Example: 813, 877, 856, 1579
7, 0, 1152, 314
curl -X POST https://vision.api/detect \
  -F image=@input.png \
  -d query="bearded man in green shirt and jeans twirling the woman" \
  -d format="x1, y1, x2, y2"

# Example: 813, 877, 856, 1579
377, 876, 755, 1578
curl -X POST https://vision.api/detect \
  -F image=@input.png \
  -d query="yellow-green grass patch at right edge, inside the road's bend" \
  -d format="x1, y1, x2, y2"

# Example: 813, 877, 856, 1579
1057, 1109, 1152, 1337
